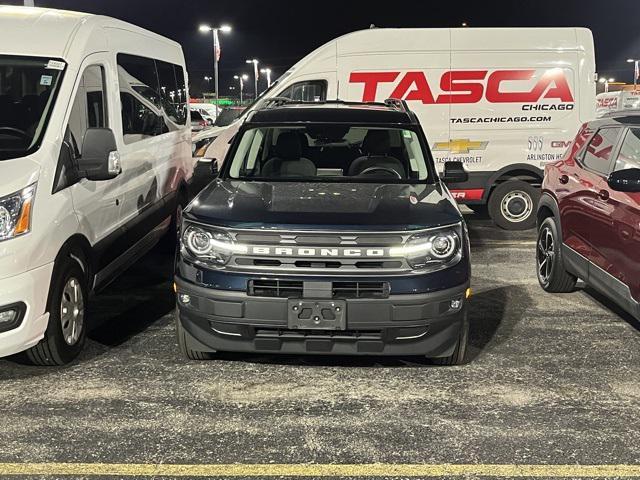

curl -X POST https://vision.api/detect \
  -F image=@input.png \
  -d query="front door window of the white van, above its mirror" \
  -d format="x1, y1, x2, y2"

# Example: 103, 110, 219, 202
68, 65, 108, 154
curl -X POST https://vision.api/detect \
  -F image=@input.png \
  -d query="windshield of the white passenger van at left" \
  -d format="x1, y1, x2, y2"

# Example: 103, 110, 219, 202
0, 56, 65, 160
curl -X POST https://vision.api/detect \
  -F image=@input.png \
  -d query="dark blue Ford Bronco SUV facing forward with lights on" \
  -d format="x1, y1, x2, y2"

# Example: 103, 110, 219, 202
175, 101, 470, 364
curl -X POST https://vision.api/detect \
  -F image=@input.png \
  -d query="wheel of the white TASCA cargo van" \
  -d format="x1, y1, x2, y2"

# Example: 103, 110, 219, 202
489, 180, 540, 230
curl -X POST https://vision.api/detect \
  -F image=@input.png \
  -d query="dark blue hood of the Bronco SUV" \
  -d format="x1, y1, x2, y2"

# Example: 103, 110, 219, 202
185, 179, 462, 230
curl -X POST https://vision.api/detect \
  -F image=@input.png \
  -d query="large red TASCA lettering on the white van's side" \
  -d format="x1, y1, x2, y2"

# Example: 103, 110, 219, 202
349, 69, 574, 105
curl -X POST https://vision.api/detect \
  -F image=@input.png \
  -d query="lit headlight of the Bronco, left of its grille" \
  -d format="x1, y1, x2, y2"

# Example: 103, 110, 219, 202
182, 225, 248, 266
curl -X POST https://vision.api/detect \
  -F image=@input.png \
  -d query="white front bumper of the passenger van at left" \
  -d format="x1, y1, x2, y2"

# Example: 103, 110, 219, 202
0, 263, 53, 357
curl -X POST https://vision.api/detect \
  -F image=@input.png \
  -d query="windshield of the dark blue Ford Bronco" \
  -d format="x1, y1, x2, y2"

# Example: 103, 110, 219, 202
228, 124, 429, 183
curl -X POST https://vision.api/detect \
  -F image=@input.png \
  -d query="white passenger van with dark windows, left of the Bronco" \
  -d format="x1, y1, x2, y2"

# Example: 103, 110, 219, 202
0, 6, 193, 365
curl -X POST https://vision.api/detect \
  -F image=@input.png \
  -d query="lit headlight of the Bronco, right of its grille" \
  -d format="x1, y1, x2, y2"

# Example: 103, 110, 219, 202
390, 225, 462, 270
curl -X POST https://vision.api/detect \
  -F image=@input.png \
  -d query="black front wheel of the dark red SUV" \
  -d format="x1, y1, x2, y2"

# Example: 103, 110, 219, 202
536, 217, 577, 293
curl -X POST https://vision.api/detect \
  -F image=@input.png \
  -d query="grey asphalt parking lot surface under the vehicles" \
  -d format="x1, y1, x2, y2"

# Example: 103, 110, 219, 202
0, 216, 640, 478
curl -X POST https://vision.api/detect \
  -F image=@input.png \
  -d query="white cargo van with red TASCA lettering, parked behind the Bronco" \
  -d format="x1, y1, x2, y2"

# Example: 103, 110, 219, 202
206, 28, 596, 229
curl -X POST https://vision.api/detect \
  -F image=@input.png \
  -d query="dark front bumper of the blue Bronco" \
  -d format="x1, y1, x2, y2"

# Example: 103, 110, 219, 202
175, 277, 469, 357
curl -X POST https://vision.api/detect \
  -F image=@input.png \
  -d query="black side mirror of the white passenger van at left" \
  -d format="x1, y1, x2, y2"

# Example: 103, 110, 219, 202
78, 128, 122, 182
